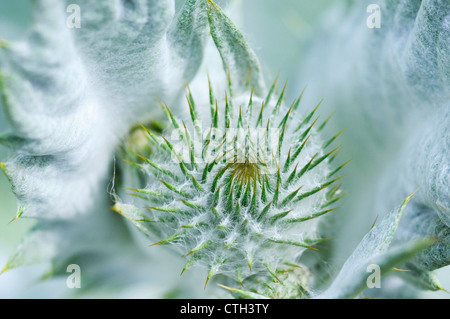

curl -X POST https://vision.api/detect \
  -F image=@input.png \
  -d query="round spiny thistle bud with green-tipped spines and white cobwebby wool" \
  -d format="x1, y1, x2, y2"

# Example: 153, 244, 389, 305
114, 80, 346, 286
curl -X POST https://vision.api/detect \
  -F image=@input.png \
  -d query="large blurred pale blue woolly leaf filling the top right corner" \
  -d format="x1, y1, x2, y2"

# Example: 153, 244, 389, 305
299, 0, 450, 152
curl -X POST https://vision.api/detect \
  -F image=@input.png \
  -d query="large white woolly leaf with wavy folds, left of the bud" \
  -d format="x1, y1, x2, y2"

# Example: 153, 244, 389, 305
0, 0, 208, 218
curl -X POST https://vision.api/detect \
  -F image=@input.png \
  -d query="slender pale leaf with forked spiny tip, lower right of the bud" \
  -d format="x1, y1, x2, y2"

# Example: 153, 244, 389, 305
317, 195, 434, 299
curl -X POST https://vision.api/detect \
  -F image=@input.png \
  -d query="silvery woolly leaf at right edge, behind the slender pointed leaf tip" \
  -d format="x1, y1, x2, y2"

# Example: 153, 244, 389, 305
378, 107, 450, 279
